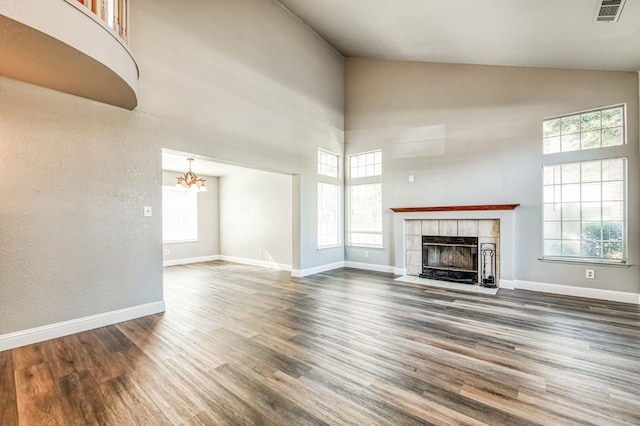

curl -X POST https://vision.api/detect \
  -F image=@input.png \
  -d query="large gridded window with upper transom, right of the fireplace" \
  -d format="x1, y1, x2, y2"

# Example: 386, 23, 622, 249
543, 106, 627, 262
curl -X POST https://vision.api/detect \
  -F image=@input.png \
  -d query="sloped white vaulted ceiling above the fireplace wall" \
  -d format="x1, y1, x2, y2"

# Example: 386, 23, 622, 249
279, 0, 640, 71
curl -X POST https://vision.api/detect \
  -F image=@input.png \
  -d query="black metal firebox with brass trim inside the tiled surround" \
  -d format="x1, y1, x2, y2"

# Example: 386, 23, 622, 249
420, 235, 478, 284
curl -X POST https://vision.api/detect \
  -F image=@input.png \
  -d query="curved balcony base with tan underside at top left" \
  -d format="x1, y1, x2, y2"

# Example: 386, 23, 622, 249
0, 0, 138, 109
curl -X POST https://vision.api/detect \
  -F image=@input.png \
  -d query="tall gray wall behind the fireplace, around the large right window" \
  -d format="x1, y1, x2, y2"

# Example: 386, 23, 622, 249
345, 59, 640, 293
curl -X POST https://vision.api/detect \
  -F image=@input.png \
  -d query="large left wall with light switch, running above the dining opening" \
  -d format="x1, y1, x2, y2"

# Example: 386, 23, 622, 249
0, 0, 344, 335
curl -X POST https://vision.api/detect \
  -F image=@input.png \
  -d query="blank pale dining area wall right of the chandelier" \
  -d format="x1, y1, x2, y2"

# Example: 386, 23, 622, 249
220, 170, 293, 268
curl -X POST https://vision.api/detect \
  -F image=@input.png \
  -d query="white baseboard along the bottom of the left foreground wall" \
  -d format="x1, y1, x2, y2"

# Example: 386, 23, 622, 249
0, 300, 165, 352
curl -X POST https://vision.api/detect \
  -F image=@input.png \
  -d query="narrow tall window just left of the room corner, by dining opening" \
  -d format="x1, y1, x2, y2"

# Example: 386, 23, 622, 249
318, 149, 340, 248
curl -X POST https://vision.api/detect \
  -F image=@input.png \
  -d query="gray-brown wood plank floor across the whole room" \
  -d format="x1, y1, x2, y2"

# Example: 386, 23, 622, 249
0, 262, 640, 426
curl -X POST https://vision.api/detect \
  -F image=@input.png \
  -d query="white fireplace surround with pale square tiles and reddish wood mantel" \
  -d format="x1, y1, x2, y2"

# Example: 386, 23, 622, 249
392, 205, 517, 285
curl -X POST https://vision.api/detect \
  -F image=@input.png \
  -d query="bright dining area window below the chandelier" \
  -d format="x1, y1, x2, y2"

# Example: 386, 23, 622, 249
162, 186, 198, 243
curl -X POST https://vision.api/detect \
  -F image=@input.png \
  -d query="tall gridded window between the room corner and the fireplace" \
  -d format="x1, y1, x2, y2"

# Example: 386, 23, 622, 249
347, 150, 382, 247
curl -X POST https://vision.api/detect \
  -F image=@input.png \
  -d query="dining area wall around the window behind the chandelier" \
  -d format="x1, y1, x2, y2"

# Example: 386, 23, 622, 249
162, 171, 220, 261
